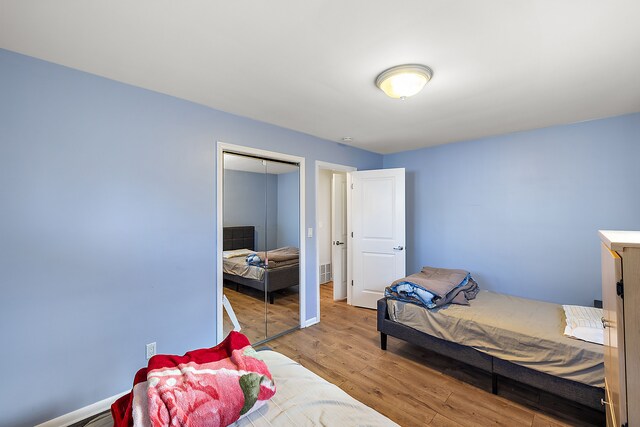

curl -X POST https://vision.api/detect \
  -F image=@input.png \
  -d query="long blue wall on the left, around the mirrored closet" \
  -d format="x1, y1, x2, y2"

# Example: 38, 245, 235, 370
0, 50, 382, 426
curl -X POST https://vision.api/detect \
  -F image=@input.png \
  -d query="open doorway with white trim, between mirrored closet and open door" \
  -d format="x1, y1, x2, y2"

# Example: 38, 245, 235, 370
316, 161, 356, 312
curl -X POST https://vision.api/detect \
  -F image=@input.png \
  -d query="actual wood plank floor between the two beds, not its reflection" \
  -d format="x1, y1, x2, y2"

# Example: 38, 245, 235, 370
268, 284, 604, 427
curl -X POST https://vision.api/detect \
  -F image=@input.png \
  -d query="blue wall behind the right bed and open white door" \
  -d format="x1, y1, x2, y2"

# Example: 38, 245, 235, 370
384, 114, 640, 305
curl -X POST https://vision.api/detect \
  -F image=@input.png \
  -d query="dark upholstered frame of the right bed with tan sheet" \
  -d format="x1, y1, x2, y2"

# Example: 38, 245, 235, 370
378, 298, 604, 412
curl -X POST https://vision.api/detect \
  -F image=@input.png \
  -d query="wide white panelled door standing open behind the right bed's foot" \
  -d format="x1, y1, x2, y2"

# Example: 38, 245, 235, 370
350, 168, 406, 308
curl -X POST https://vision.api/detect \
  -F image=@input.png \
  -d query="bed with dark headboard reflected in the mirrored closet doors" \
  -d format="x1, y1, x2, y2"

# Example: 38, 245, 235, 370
222, 226, 300, 304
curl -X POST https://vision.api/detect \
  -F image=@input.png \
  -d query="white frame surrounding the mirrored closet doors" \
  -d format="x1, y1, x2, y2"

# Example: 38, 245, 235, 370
214, 141, 306, 343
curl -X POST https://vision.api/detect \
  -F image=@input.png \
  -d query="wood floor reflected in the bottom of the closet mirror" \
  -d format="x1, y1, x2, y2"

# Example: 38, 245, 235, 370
223, 284, 300, 343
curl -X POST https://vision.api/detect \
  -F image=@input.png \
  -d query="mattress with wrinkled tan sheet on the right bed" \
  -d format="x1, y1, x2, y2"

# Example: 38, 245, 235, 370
388, 291, 604, 387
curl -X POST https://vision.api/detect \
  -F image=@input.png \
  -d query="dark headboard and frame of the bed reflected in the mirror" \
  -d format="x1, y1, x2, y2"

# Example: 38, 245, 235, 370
222, 225, 300, 304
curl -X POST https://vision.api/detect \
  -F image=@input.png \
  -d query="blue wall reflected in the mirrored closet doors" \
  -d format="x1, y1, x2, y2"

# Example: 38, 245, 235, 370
223, 169, 278, 251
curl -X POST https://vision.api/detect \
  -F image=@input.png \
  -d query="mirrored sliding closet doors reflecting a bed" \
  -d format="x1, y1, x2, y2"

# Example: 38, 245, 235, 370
222, 153, 300, 344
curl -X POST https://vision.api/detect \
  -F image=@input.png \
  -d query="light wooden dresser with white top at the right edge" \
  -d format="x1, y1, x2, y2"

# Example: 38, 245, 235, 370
600, 231, 640, 427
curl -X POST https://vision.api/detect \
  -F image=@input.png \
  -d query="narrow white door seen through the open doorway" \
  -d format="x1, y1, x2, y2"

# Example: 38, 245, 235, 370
331, 173, 347, 300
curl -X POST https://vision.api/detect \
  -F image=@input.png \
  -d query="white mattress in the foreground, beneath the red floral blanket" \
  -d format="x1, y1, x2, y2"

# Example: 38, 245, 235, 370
87, 350, 397, 427
